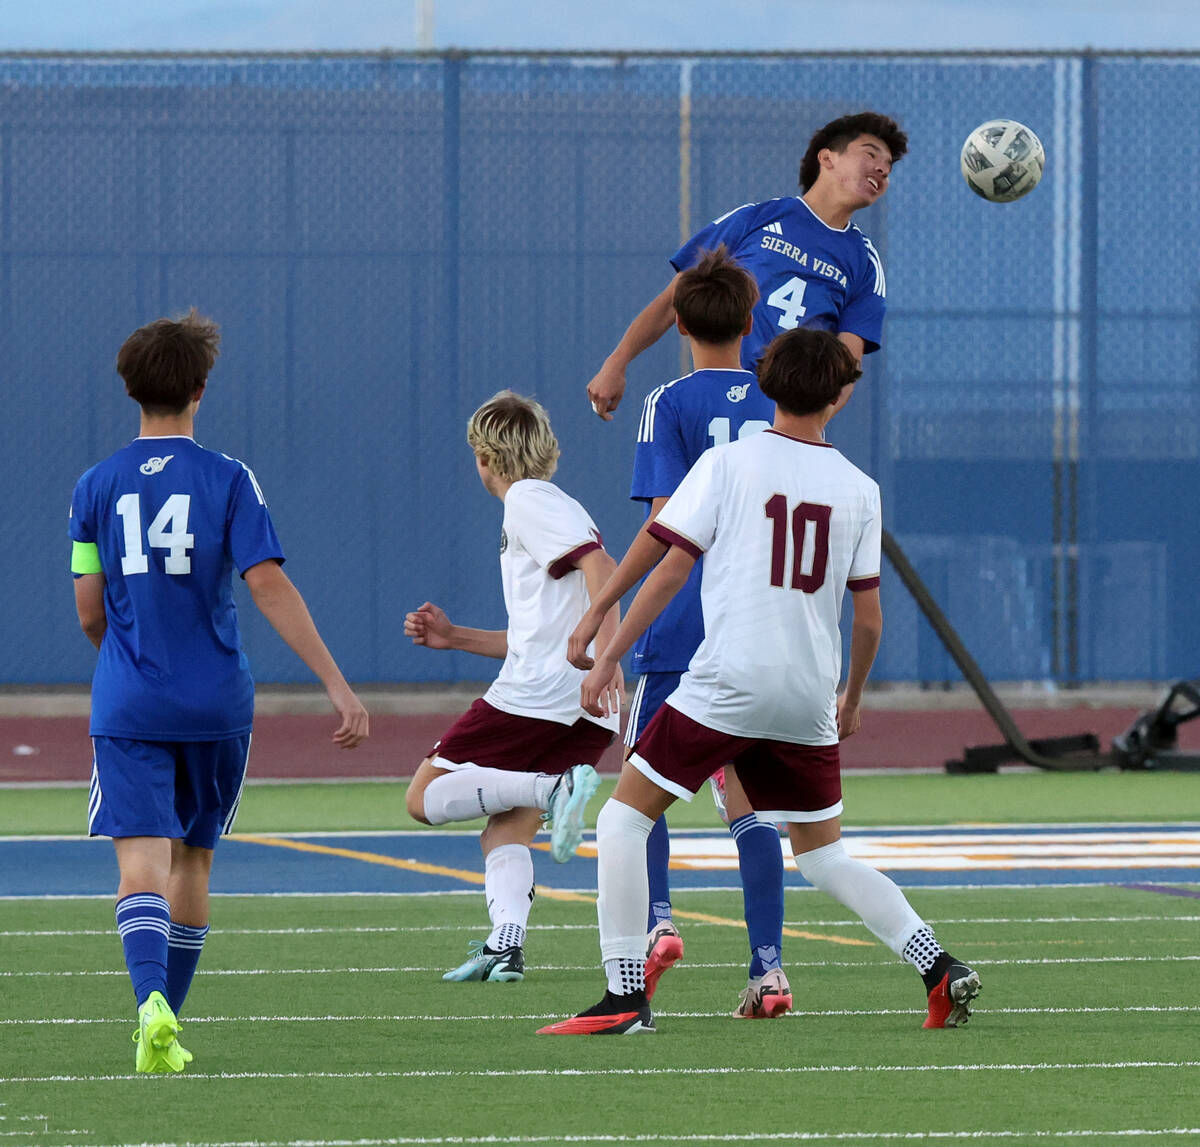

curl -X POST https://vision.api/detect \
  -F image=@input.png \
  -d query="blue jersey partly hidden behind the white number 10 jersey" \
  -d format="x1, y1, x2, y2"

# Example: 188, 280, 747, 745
630, 370, 775, 673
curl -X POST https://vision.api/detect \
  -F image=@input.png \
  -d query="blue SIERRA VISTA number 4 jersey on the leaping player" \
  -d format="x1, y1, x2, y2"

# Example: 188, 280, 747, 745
671, 196, 887, 371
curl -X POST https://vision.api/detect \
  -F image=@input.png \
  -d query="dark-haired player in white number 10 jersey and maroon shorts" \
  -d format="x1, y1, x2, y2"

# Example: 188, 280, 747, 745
541, 330, 979, 1035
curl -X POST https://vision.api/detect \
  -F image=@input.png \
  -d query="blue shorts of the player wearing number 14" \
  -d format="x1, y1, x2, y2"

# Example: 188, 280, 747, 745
88, 733, 250, 848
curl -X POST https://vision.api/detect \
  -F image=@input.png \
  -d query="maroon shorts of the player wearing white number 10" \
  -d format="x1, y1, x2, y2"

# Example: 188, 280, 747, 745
629, 704, 841, 821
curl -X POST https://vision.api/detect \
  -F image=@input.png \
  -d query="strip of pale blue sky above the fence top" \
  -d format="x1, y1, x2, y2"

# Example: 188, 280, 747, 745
7, 0, 1200, 50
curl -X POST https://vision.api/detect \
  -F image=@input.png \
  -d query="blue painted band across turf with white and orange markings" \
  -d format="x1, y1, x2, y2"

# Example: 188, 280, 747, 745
0, 824, 1200, 896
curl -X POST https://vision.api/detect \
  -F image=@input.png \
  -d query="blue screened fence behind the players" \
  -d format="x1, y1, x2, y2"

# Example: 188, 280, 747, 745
0, 55, 1200, 683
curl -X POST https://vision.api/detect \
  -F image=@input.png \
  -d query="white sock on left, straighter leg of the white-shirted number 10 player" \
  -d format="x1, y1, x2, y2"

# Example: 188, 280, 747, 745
596, 799, 654, 991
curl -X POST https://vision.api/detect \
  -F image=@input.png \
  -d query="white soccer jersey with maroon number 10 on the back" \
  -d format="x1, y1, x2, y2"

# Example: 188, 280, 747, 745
650, 431, 882, 745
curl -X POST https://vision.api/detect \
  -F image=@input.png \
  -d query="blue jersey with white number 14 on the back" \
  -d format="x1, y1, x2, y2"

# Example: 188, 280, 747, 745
71, 437, 283, 741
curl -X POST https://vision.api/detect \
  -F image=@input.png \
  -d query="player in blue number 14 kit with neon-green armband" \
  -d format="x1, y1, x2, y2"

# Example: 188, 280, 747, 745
71, 310, 367, 1073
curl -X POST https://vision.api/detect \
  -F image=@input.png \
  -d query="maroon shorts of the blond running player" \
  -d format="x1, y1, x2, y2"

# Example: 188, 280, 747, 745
430, 697, 613, 773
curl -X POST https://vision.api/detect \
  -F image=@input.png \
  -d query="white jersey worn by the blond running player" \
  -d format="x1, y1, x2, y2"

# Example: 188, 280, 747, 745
484, 478, 620, 732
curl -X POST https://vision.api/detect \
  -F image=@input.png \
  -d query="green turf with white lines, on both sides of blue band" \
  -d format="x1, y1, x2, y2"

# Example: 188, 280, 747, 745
0, 774, 1200, 1147
